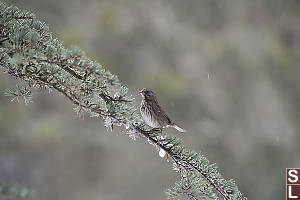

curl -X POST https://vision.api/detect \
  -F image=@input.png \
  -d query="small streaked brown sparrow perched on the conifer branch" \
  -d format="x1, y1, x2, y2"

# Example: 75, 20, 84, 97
139, 88, 186, 132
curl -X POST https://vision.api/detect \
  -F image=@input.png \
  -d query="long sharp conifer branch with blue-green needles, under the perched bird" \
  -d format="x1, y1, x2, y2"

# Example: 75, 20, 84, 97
0, 3, 246, 200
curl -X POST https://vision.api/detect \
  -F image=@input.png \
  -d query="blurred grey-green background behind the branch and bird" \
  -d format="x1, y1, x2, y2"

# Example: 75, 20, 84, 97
0, 0, 300, 200
